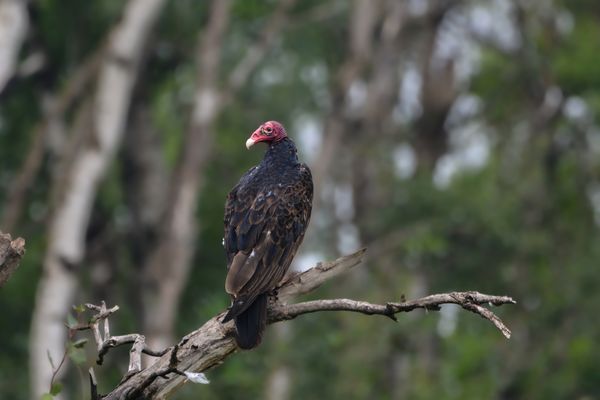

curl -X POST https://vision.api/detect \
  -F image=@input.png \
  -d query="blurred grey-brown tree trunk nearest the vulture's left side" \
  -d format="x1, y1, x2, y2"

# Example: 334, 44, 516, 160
142, 0, 231, 354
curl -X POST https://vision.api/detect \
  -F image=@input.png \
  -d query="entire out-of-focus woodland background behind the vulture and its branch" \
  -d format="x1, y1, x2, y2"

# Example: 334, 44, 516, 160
0, 0, 600, 400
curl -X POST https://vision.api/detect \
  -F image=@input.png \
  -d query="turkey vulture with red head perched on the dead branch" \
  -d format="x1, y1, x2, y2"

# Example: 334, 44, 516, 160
223, 121, 313, 349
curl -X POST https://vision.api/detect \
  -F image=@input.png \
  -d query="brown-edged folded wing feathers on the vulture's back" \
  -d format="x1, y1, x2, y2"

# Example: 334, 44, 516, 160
224, 164, 313, 318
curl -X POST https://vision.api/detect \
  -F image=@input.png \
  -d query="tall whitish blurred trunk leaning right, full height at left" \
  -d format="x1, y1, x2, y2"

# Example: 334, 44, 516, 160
30, 0, 165, 398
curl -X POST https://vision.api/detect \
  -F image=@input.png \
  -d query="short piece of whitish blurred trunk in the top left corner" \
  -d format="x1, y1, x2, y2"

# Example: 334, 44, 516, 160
0, 0, 29, 92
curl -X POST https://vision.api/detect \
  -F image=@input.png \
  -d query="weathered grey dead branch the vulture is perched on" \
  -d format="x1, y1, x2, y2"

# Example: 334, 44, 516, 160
90, 249, 515, 400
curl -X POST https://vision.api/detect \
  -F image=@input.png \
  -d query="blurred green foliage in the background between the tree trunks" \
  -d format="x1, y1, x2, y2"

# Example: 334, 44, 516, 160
0, 0, 600, 400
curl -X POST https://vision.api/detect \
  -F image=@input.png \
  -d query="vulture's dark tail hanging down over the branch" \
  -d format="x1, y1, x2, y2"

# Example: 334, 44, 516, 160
234, 293, 268, 350
